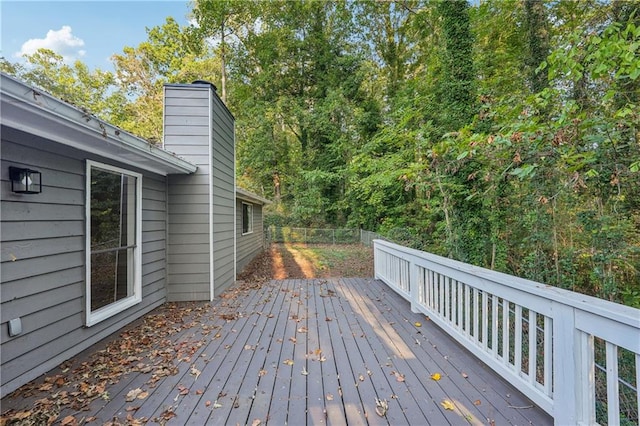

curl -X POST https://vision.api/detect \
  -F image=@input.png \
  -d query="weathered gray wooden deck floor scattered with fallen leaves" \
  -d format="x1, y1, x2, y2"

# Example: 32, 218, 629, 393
2, 278, 553, 425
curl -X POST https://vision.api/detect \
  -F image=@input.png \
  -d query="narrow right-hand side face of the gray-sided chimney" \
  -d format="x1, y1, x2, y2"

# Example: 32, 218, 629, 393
211, 96, 236, 295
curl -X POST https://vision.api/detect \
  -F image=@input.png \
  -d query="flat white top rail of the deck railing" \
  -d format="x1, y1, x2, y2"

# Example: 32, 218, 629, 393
374, 239, 640, 328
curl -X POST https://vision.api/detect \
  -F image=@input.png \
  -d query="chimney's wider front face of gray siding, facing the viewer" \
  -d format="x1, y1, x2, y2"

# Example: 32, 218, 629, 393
164, 86, 211, 301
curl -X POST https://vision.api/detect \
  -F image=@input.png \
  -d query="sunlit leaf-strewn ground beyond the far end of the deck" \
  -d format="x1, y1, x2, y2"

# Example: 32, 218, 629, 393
238, 244, 374, 282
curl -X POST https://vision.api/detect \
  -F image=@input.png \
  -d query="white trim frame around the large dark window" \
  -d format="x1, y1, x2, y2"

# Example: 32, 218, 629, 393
85, 160, 142, 327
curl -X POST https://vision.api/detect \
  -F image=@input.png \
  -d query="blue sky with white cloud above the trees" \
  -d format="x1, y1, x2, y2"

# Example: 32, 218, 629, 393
0, 0, 191, 70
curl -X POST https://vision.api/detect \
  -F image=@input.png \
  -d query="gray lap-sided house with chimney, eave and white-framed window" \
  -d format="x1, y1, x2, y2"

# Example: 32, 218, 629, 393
0, 74, 262, 397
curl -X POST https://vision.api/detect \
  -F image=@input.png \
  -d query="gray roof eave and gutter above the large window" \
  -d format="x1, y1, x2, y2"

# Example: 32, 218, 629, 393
0, 73, 198, 176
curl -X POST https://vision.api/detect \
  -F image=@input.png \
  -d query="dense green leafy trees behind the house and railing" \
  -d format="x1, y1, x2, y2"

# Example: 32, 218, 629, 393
0, 0, 640, 306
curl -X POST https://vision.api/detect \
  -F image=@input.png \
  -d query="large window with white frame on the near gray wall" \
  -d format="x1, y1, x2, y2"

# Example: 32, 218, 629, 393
86, 161, 142, 326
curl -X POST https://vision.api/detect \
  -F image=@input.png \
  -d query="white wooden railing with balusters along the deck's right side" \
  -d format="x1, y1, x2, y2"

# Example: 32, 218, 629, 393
374, 240, 640, 425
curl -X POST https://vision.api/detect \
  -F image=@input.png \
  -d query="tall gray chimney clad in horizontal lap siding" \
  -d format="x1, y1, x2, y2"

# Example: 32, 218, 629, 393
163, 80, 236, 301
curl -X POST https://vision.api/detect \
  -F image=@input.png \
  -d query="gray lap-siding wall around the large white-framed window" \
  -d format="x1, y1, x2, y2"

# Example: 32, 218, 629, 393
0, 127, 167, 396
